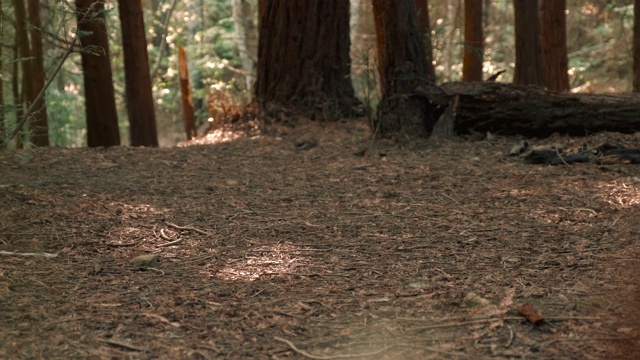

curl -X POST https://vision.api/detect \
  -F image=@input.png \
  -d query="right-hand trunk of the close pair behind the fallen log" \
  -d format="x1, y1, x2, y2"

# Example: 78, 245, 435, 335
541, 0, 569, 91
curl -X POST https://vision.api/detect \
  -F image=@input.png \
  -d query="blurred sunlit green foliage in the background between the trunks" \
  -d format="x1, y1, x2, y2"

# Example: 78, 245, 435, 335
2, 0, 633, 147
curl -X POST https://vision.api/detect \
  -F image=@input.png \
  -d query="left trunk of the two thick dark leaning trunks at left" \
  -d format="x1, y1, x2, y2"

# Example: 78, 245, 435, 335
76, 0, 120, 147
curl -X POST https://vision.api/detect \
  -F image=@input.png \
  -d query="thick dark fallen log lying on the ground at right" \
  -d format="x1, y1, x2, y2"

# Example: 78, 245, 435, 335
422, 82, 640, 137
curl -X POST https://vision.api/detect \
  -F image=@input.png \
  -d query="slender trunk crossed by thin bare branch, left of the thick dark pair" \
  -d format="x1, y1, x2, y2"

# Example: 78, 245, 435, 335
28, 0, 49, 147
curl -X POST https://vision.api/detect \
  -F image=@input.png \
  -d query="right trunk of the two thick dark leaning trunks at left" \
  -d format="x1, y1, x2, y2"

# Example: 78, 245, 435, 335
118, 0, 158, 146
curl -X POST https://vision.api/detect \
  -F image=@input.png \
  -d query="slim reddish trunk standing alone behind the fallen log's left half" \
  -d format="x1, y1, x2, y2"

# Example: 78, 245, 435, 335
462, 0, 484, 81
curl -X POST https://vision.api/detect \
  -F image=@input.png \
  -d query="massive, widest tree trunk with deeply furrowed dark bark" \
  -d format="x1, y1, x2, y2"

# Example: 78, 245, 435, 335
256, 0, 361, 120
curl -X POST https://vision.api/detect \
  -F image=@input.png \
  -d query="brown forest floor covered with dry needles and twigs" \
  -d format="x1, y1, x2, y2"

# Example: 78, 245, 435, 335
0, 122, 640, 359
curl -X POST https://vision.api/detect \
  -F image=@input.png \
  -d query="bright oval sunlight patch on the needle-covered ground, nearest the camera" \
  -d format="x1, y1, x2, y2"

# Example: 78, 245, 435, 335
215, 244, 308, 281
